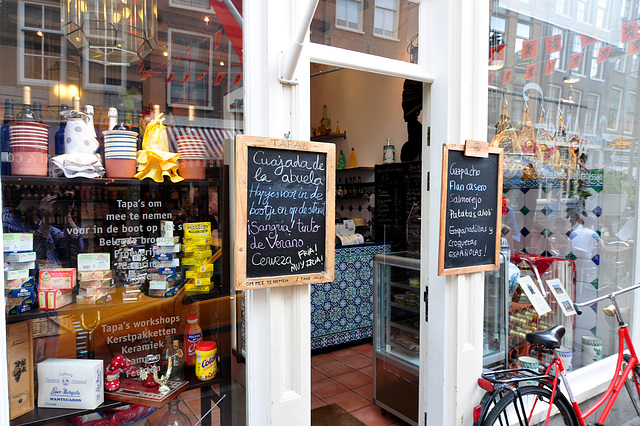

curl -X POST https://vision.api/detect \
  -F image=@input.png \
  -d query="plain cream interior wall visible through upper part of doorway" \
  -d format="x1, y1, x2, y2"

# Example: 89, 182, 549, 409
310, 64, 407, 166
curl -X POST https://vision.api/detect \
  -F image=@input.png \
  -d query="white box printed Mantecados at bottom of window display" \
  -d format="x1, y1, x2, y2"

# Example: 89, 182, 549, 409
38, 358, 104, 410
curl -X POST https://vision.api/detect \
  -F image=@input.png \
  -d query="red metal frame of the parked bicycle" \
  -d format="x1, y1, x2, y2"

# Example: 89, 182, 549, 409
545, 324, 640, 426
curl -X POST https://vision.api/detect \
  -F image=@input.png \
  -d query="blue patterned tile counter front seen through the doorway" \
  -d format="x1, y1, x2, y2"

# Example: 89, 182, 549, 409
311, 244, 391, 350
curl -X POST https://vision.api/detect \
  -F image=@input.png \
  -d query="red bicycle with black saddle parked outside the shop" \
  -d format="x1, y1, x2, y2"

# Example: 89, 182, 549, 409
473, 283, 640, 426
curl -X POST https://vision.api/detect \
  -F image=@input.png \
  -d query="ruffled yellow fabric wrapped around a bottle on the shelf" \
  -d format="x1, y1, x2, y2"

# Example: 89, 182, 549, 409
135, 114, 184, 183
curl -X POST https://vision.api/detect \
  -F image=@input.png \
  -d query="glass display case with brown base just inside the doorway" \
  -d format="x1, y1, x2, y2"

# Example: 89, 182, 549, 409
373, 252, 421, 424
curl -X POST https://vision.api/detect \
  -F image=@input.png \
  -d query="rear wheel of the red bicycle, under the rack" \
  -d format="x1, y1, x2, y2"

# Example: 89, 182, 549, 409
482, 386, 578, 426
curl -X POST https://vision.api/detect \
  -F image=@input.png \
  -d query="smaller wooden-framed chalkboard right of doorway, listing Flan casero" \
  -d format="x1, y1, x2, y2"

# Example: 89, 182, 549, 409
438, 141, 503, 275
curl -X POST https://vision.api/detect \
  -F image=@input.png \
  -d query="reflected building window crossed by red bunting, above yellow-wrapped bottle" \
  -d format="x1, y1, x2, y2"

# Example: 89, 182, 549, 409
167, 30, 211, 108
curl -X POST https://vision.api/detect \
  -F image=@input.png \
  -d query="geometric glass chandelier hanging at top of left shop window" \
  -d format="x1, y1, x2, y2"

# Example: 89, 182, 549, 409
62, 0, 158, 65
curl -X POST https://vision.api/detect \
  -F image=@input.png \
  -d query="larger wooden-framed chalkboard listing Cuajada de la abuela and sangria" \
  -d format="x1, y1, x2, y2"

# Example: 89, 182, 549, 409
234, 135, 336, 290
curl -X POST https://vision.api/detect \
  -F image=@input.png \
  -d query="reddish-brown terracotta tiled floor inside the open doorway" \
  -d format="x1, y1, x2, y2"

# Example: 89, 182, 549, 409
311, 343, 407, 426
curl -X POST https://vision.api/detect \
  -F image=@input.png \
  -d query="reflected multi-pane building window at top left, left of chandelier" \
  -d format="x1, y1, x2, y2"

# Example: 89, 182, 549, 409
18, 3, 63, 83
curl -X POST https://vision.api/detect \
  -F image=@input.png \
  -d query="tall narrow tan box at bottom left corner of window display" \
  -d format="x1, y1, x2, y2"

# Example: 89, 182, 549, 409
7, 321, 35, 420
